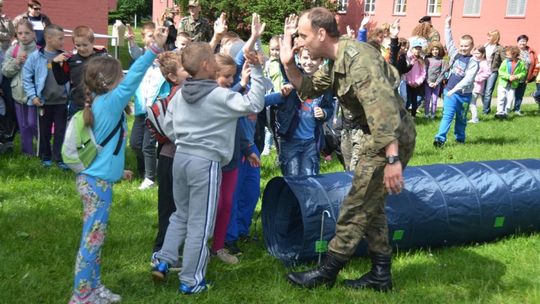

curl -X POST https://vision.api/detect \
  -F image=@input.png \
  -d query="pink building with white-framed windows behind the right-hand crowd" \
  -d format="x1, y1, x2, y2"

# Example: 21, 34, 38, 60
337, 0, 540, 50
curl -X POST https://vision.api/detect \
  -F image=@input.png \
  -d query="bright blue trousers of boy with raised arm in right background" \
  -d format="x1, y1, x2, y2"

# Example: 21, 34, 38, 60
435, 90, 472, 143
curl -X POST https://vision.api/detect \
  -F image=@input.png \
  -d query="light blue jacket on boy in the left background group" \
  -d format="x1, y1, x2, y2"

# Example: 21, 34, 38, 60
23, 48, 69, 105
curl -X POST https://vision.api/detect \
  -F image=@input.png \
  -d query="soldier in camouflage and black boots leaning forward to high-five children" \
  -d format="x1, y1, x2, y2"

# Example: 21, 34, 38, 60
280, 8, 416, 291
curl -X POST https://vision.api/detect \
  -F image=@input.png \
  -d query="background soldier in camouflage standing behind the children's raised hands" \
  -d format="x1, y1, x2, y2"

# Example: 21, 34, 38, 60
178, 0, 212, 42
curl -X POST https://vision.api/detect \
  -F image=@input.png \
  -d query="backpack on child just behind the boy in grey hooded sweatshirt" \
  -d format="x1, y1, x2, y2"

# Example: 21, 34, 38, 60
146, 86, 180, 145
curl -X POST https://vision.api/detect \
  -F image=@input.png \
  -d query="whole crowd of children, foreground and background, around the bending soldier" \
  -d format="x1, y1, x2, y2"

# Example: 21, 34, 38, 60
0, 1, 540, 303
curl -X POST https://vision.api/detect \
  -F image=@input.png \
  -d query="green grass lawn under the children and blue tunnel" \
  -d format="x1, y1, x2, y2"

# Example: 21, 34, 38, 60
0, 105, 540, 304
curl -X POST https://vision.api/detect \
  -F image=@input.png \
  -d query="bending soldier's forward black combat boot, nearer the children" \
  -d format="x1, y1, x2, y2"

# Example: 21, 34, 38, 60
287, 252, 347, 288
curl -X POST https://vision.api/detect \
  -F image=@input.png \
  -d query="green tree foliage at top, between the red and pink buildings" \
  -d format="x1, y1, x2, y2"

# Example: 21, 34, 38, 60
190, 0, 336, 41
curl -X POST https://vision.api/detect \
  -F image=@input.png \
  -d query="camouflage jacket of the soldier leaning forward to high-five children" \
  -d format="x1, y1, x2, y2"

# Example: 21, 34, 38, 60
298, 37, 408, 151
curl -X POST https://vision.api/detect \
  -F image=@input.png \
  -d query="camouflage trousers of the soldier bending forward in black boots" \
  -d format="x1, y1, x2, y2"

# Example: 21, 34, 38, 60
329, 115, 416, 258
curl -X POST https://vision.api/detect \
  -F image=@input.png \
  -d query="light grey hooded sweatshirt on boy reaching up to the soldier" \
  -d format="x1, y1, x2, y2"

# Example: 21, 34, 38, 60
165, 66, 264, 165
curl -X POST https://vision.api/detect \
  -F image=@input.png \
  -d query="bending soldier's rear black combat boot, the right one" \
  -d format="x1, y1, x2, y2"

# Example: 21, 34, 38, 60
343, 252, 392, 292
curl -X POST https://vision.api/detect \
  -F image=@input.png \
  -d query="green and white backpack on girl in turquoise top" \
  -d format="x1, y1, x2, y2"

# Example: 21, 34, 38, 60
62, 111, 124, 173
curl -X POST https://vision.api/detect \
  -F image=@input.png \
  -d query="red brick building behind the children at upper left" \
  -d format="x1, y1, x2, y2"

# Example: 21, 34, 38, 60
4, 0, 117, 50
